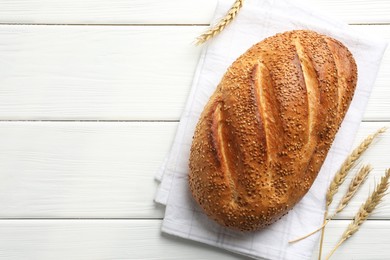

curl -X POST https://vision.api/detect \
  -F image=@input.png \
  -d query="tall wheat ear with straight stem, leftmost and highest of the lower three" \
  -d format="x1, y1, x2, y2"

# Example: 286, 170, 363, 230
318, 127, 387, 260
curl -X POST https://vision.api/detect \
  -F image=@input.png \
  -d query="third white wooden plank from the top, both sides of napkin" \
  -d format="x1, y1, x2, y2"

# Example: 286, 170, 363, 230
0, 122, 390, 219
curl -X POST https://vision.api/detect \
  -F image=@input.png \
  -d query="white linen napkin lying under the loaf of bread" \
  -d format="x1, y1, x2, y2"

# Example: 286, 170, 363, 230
155, 0, 386, 259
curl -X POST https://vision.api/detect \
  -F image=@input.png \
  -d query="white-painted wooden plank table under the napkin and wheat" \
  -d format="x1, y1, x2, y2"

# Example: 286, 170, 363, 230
0, 0, 390, 259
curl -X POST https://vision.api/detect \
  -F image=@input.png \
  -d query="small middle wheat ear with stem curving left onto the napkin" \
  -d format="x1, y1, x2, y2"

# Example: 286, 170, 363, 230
289, 165, 372, 243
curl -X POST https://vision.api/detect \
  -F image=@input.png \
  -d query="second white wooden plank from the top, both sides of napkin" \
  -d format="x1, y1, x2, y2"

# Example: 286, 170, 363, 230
0, 25, 390, 121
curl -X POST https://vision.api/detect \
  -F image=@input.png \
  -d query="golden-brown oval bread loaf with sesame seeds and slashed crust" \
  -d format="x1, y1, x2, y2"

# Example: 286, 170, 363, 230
189, 30, 357, 231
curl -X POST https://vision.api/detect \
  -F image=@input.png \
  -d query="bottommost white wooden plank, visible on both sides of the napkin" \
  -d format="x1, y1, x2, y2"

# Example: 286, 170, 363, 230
0, 220, 390, 260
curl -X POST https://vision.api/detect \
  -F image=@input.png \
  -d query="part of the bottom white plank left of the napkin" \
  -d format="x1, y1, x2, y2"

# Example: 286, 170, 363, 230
0, 220, 241, 260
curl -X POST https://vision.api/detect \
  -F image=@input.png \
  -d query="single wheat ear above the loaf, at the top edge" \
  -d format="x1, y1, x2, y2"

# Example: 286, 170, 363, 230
196, 0, 244, 45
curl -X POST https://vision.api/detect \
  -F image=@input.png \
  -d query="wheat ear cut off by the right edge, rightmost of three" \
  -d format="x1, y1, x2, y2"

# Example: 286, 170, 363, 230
326, 169, 390, 259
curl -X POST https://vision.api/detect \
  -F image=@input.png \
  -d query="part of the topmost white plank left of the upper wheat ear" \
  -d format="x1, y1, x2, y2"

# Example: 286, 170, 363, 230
0, 0, 217, 24
